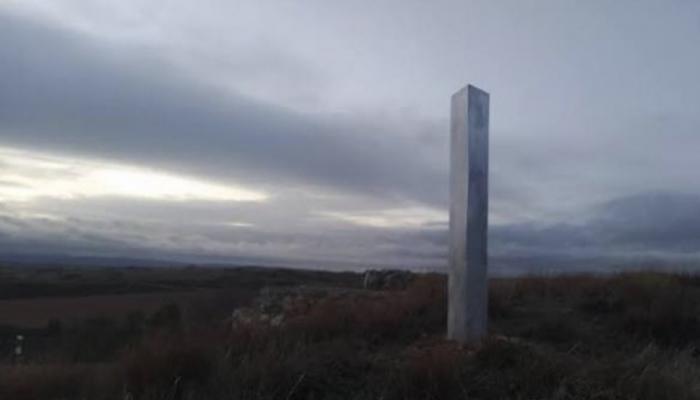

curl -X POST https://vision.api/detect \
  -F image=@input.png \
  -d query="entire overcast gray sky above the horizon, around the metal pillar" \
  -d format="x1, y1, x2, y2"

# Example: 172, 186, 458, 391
0, 0, 700, 267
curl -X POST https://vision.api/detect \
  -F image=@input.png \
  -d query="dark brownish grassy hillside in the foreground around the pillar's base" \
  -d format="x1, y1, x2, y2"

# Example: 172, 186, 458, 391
0, 272, 700, 400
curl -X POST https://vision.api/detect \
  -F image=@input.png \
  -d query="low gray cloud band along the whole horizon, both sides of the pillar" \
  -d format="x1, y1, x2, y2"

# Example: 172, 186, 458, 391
0, 192, 700, 274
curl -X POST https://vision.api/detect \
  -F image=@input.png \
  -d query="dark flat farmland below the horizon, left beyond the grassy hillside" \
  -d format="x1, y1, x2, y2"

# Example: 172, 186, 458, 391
0, 265, 359, 329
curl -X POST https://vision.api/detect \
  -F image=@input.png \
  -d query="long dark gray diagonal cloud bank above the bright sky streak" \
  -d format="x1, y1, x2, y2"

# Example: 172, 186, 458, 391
0, 10, 446, 204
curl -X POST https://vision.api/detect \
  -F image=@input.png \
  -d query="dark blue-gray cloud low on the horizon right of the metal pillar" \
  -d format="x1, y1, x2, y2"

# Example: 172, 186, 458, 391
492, 192, 700, 261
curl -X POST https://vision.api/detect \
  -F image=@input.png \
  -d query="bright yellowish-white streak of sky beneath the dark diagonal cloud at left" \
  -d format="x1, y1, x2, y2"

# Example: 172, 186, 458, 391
0, 147, 267, 203
